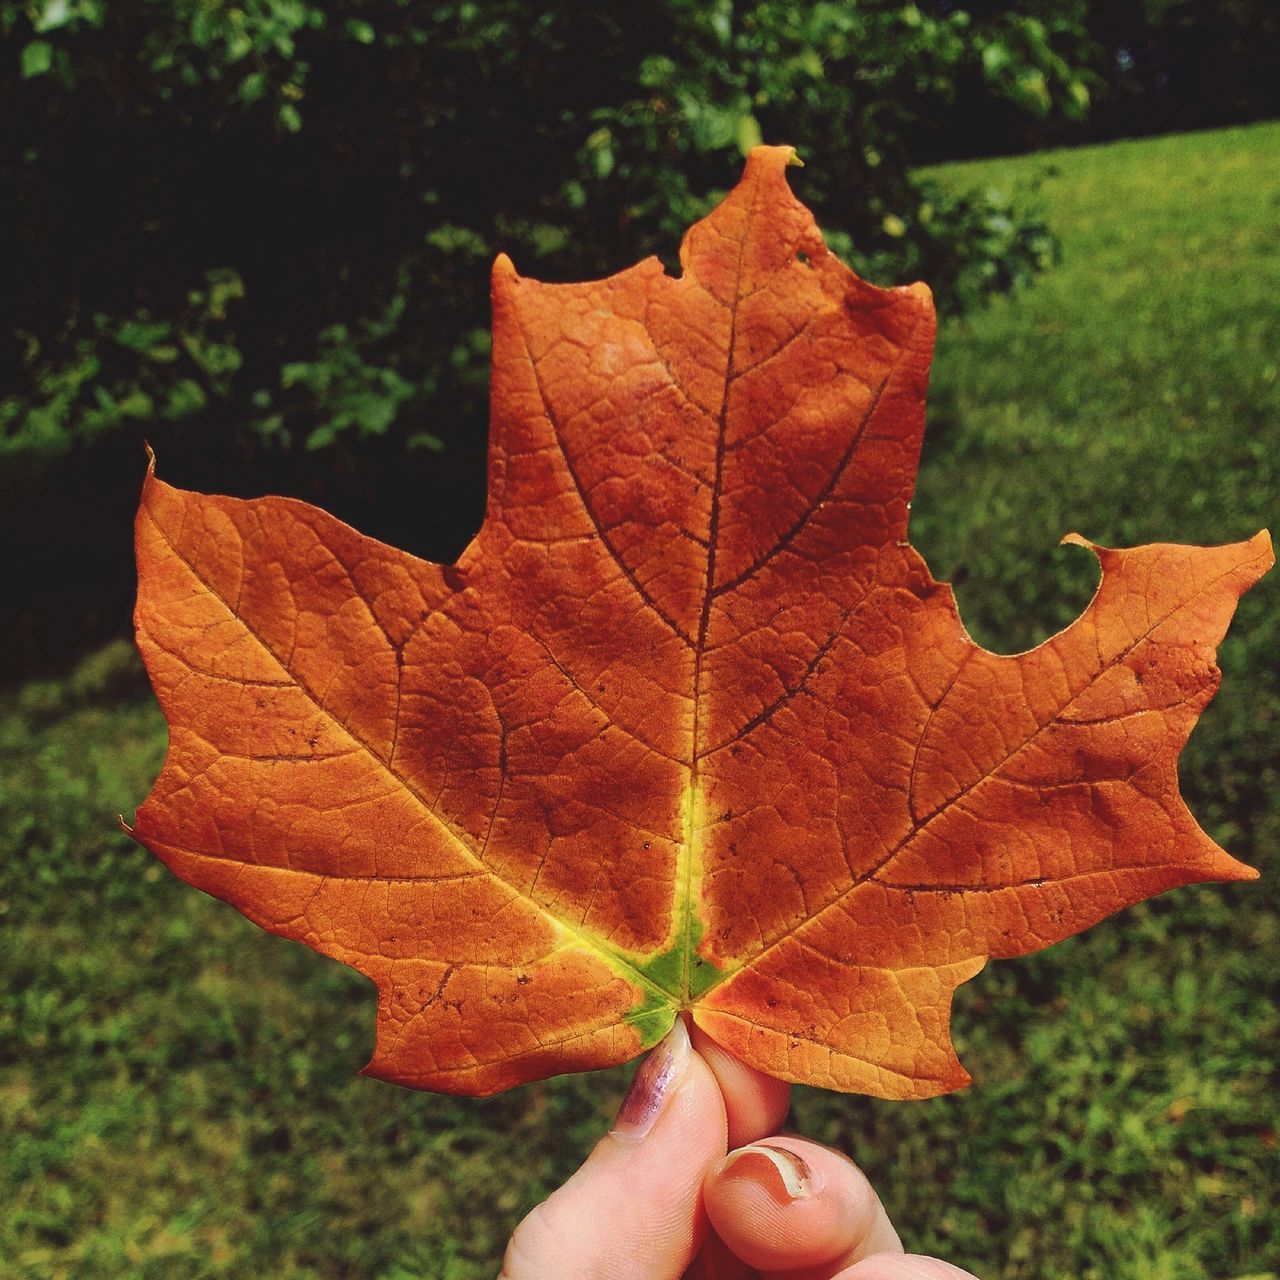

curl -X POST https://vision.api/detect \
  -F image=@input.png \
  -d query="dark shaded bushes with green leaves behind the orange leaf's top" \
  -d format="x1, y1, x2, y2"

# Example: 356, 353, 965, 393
0, 0, 1087, 471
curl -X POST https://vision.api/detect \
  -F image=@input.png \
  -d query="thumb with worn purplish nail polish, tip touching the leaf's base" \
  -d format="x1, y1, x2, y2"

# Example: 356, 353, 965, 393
499, 1019, 726, 1280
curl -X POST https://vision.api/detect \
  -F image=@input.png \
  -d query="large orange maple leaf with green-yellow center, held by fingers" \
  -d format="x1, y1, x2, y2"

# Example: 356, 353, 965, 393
134, 147, 1271, 1098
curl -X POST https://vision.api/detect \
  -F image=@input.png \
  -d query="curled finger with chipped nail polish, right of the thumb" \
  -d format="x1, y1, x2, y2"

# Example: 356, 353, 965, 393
703, 1137, 902, 1280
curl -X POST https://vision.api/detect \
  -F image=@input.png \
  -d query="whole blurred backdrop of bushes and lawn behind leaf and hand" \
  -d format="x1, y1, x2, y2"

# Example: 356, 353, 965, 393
0, 0, 1280, 1280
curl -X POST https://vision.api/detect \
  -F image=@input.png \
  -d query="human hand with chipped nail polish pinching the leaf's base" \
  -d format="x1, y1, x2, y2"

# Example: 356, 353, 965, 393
499, 1020, 974, 1280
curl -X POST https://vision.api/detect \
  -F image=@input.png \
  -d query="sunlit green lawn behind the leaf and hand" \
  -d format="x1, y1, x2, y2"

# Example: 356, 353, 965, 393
0, 125, 1280, 1280
